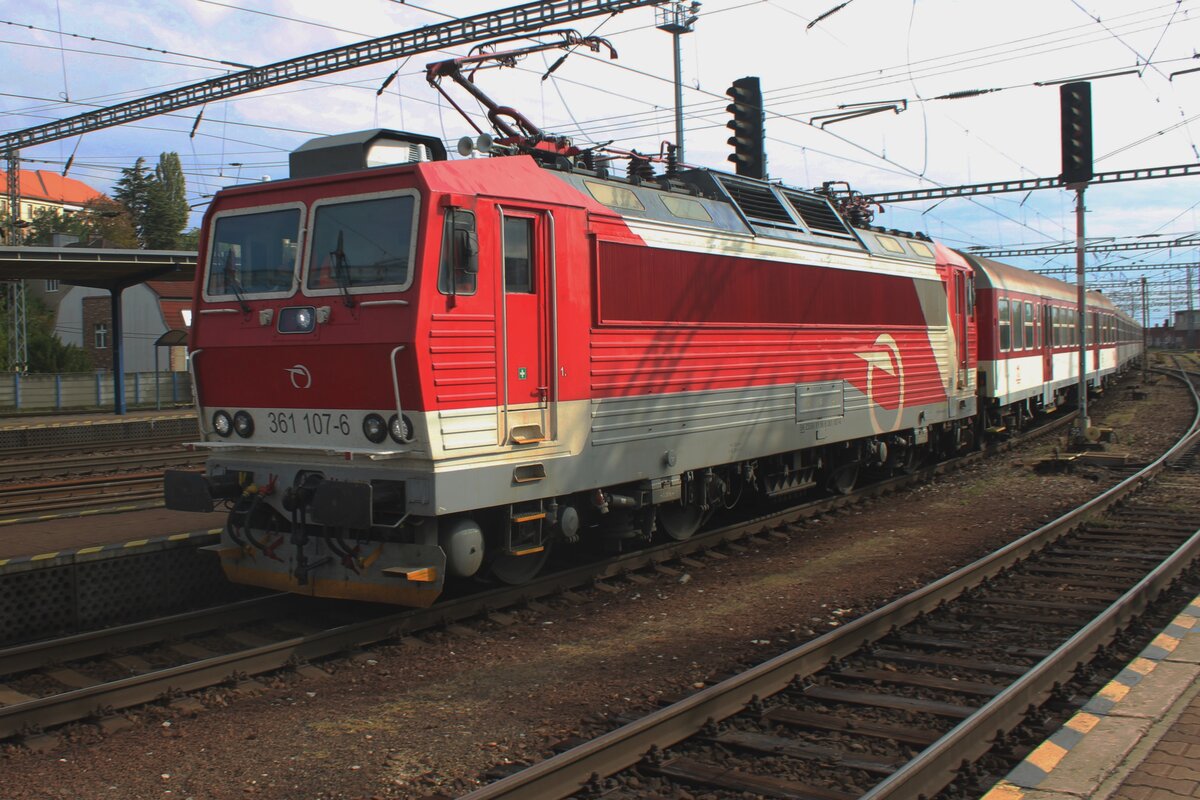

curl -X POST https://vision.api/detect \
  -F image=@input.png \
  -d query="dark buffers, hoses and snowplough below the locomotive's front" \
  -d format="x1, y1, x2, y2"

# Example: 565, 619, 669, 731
164, 470, 484, 607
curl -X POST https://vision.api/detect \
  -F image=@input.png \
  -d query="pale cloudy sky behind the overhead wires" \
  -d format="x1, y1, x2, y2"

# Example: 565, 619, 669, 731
0, 0, 1200, 324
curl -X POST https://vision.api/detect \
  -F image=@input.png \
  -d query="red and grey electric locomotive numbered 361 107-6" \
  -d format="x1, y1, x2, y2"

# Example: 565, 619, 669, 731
167, 125, 993, 606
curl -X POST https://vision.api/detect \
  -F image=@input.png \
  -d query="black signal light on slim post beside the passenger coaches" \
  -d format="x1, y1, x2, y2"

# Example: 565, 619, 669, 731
1058, 80, 1093, 441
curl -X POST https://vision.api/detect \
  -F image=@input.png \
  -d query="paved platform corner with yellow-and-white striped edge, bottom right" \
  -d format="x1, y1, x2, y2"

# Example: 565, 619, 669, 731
983, 597, 1200, 800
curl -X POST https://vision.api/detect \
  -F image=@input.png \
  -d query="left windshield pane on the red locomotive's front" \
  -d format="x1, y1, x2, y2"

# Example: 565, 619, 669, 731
208, 209, 300, 299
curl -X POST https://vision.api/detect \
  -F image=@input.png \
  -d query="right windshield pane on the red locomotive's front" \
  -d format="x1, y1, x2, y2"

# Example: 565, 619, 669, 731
307, 194, 415, 290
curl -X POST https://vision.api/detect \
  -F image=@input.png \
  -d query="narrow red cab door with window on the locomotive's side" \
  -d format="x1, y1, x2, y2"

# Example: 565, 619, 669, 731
499, 207, 557, 445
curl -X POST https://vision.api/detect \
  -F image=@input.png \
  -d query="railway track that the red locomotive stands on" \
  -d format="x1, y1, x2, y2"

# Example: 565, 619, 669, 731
0, 371, 1171, 753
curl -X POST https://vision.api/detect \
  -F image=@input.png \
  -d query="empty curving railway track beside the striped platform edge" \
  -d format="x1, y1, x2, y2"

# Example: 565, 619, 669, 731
453, 367, 1200, 800
